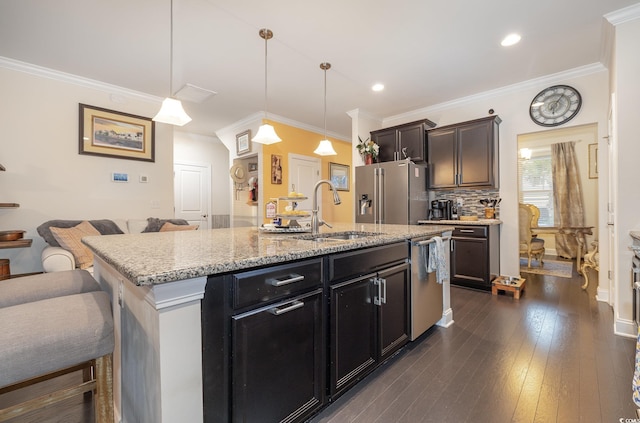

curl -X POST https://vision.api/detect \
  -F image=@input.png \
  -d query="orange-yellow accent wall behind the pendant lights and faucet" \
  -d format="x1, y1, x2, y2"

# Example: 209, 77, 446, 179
260, 121, 354, 223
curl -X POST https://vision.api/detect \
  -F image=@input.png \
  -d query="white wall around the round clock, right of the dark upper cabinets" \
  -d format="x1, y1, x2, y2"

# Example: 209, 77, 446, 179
364, 65, 608, 275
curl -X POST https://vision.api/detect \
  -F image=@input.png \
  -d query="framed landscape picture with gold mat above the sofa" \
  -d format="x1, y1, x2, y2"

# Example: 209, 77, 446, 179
78, 104, 155, 162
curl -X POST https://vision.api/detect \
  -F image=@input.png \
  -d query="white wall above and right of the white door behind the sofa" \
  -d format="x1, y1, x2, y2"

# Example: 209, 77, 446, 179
173, 130, 231, 219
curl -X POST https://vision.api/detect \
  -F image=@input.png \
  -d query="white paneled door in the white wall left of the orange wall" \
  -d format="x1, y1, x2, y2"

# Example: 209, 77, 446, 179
173, 163, 211, 230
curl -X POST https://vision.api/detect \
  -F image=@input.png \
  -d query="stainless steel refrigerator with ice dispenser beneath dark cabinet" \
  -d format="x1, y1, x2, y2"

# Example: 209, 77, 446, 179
356, 161, 429, 225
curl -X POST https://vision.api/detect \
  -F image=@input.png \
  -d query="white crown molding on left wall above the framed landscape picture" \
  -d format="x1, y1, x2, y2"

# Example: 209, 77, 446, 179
0, 56, 163, 103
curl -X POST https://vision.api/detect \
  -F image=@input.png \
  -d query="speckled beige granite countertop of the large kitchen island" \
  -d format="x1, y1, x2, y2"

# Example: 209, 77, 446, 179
82, 221, 453, 285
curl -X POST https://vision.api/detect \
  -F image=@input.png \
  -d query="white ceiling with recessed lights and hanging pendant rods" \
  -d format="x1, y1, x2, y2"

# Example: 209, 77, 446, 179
0, 0, 637, 138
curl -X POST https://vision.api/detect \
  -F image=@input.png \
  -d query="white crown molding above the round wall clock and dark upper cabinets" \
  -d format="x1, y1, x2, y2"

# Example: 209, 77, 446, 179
383, 63, 607, 127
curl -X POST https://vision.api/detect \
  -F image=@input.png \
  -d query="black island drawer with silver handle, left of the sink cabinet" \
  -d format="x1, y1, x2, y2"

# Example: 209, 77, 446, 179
233, 259, 322, 309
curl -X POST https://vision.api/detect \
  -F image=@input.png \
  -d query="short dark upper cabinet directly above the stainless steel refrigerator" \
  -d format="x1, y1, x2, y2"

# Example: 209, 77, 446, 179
371, 119, 436, 163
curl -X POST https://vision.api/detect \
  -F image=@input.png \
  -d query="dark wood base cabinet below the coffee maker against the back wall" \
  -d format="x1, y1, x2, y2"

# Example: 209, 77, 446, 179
451, 225, 500, 291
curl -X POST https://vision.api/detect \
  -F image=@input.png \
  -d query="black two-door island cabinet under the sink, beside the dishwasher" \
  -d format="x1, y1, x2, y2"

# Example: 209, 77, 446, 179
329, 243, 410, 399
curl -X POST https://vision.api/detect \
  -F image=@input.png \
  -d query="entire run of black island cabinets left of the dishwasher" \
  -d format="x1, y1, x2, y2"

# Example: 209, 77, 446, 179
202, 242, 410, 423
